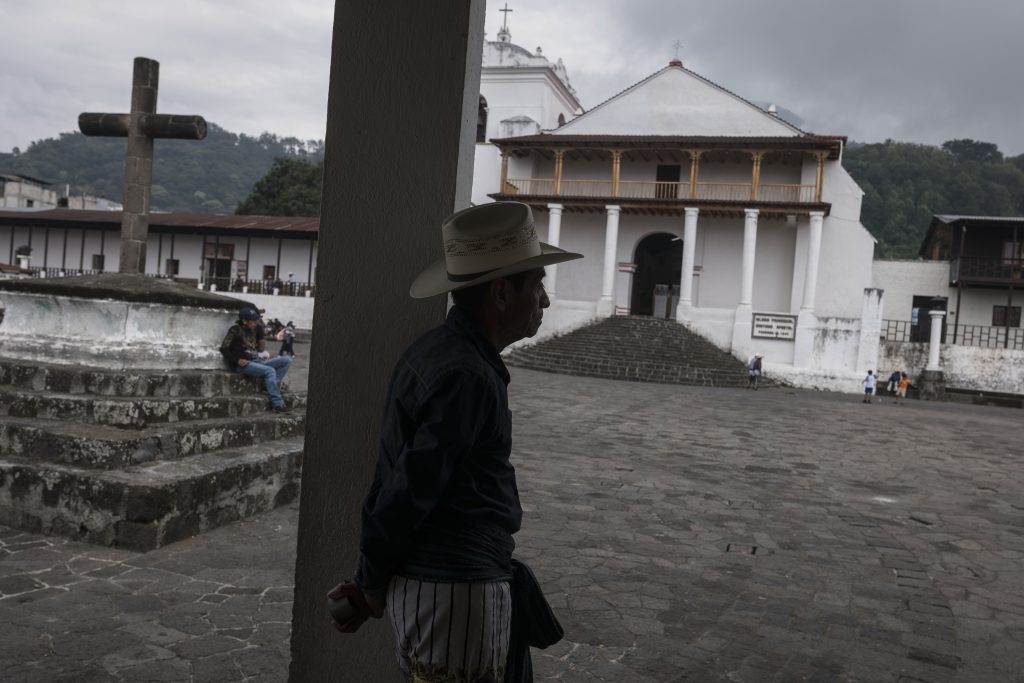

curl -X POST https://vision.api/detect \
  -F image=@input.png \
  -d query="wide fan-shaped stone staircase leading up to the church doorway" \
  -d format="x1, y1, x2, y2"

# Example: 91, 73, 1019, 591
505, 315, 746, 387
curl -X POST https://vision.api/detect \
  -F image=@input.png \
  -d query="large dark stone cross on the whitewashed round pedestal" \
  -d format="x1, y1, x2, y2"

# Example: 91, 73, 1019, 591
78, 57, 206, 274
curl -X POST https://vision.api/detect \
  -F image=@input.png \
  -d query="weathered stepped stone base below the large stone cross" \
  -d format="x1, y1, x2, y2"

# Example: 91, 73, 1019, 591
0, 358, 305, 551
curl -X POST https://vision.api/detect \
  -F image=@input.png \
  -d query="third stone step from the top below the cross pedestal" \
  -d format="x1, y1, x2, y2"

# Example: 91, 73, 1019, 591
0, 412, 305, 469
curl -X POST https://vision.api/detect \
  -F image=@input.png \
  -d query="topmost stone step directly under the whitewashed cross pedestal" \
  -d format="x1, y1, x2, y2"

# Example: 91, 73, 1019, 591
0, 358, 268, 397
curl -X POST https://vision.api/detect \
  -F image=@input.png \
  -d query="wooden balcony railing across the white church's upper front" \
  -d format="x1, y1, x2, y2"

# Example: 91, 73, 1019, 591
505, 178, 815, 204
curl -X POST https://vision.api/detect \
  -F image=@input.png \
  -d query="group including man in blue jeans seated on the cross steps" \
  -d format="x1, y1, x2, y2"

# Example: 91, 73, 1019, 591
220, 307, 295, 413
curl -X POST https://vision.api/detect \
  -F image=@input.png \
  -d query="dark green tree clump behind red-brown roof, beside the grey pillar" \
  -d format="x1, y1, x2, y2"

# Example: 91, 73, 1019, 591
234, 157, 324, 216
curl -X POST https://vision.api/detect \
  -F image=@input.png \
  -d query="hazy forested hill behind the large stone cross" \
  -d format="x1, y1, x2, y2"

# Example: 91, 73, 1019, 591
0, 124, 324, 213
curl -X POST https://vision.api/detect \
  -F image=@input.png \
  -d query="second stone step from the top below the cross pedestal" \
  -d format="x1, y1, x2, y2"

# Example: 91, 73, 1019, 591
0, 387, 306, 429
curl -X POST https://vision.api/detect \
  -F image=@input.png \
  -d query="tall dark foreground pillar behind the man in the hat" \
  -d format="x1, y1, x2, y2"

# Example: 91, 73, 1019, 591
290, 0, 484, 683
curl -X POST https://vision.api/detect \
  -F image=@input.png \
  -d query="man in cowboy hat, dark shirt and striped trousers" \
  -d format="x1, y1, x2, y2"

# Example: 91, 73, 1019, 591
331, 202, 582, 681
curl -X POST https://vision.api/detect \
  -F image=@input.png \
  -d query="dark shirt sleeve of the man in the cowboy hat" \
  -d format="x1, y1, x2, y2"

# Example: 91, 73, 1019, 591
355, 372, 496, 592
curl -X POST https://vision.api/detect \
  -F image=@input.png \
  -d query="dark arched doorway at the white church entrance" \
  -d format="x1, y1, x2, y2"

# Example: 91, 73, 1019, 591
630, 232, 683, 317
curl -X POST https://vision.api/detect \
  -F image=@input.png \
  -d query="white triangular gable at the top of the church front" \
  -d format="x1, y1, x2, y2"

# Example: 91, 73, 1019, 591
540, 59, 819, 139
